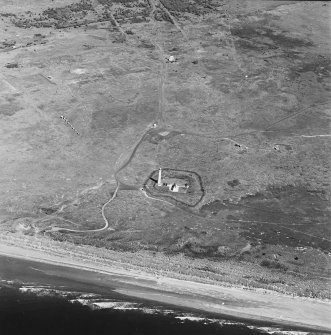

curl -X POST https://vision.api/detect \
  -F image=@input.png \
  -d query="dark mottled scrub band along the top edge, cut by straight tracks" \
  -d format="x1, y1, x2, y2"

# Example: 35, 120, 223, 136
7, 0, 213, 29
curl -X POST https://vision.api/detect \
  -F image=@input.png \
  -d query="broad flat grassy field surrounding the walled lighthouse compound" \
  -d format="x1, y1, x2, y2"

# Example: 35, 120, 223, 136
0, 0, 331, 306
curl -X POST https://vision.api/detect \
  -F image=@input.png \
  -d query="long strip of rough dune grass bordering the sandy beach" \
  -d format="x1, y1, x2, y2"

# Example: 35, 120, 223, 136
1, 234, 330, 301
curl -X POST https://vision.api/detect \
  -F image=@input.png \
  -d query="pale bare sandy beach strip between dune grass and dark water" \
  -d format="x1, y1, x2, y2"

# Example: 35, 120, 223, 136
0, 241, 331, 331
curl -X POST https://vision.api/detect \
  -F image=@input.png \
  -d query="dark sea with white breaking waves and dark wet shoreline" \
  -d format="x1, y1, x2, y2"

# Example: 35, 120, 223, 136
0, 256, 317, 335
